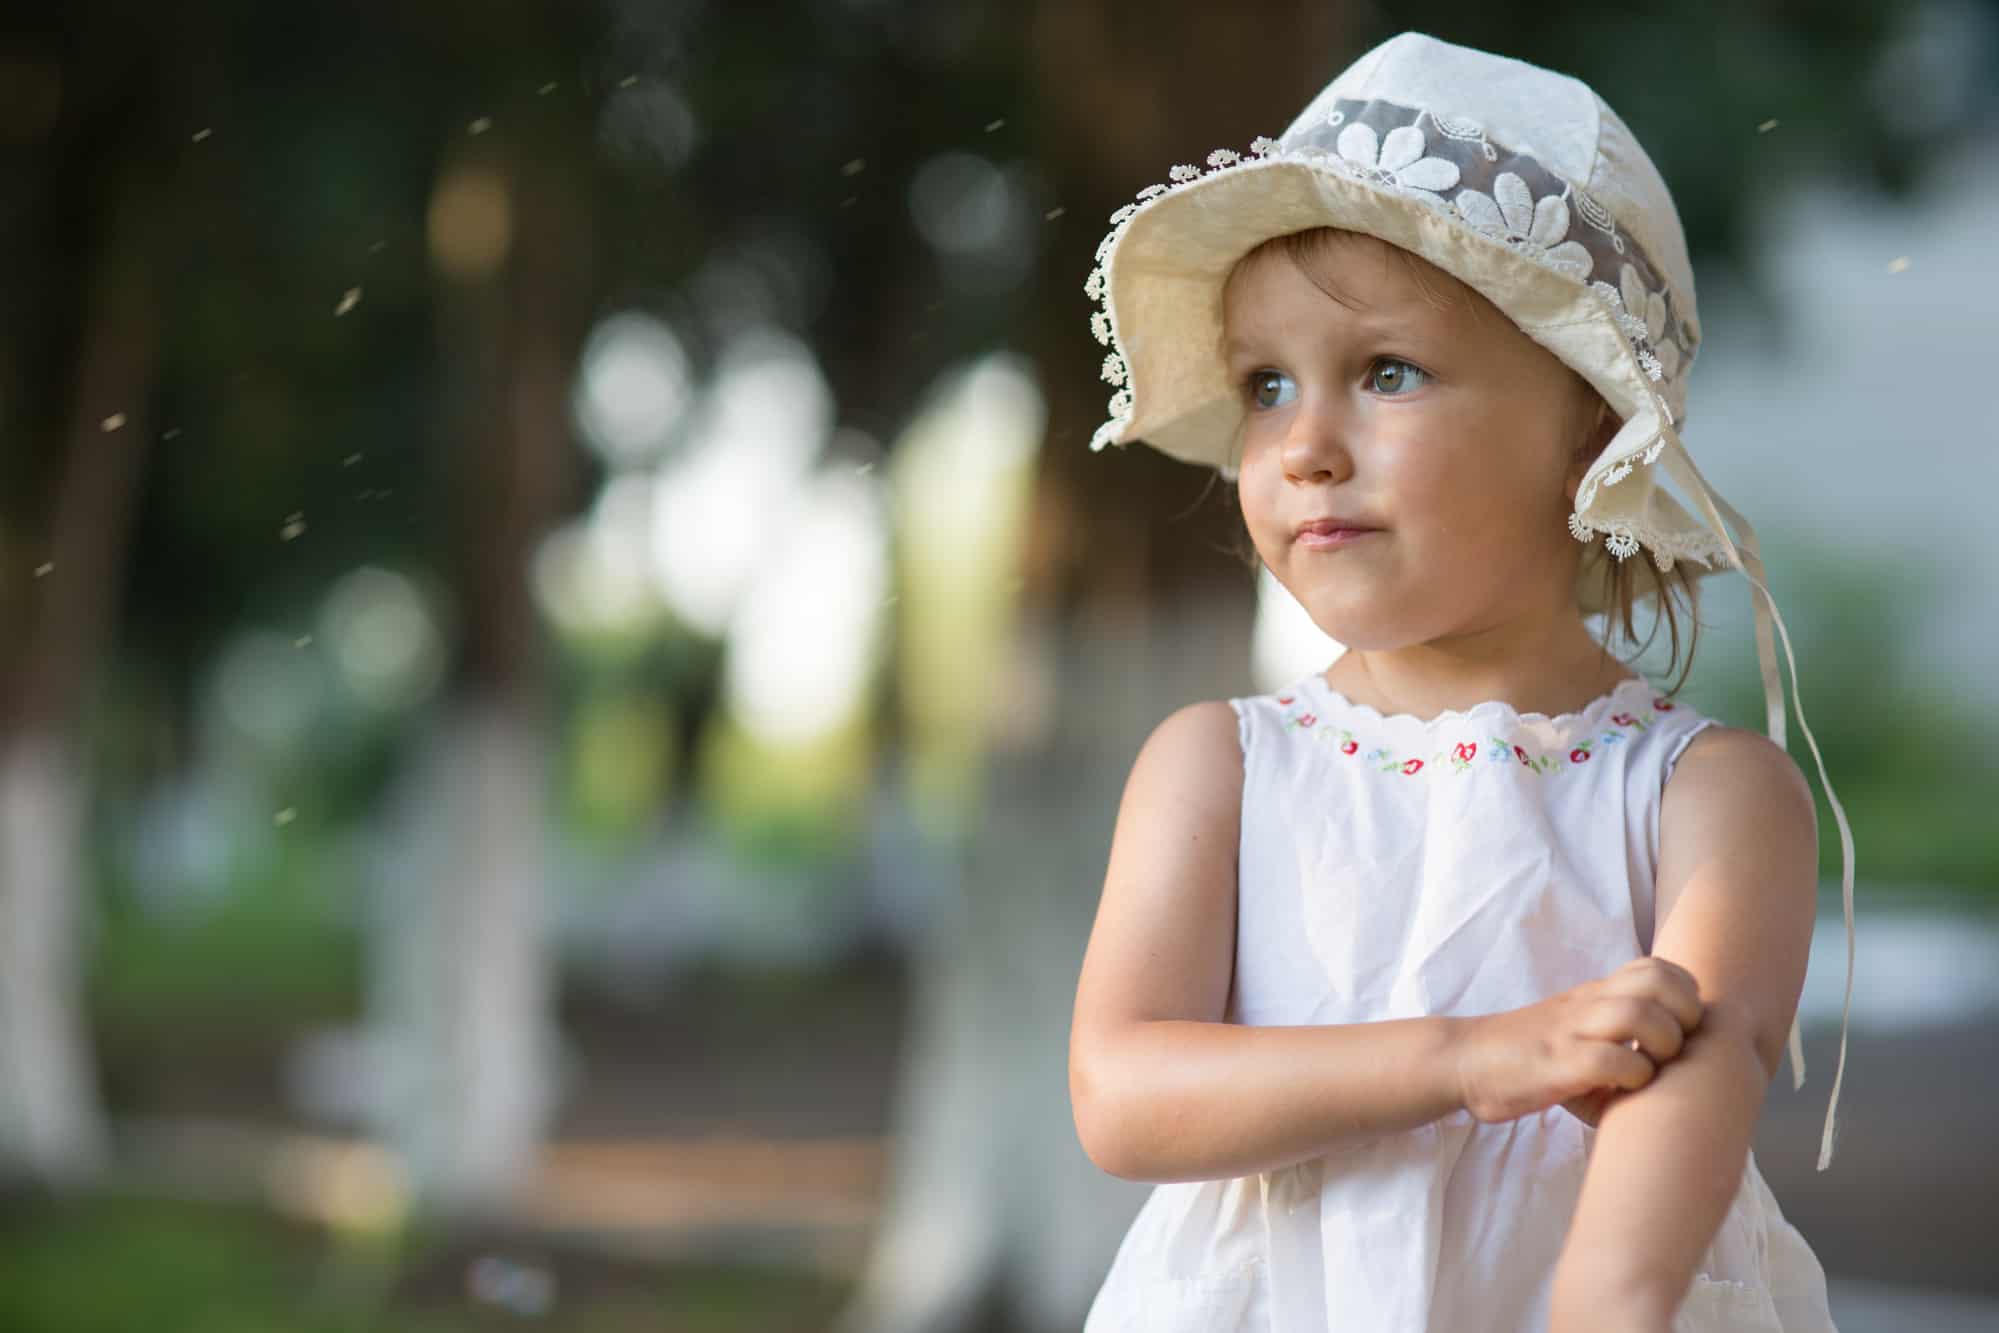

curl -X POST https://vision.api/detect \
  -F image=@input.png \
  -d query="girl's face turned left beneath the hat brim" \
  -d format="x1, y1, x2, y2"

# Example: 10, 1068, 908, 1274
1223, 234, 1617, 652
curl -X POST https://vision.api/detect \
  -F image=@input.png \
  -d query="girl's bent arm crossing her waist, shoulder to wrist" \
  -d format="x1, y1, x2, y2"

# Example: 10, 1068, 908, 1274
1069, 699, 1463, 1181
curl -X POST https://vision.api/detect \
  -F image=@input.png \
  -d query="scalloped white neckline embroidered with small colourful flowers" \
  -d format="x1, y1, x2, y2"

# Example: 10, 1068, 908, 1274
1275, 671, 1677, 777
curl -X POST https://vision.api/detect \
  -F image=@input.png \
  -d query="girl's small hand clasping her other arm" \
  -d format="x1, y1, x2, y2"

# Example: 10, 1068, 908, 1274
1453, 957, 1701, 1125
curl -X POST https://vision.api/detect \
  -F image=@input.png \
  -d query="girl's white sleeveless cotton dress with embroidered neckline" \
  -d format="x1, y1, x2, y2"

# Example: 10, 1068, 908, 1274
1083, 671, 1833, 1333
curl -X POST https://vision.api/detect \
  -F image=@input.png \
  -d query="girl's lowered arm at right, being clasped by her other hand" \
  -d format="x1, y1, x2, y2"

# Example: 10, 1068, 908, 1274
1549, 725, 1819, 1333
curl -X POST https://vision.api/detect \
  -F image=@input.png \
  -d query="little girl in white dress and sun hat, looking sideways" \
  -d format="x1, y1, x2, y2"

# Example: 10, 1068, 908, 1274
1069, 32, 1853, 1333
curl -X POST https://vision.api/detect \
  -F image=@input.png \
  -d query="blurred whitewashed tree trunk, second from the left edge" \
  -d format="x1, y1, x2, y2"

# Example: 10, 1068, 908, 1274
370, 146, 588, 1215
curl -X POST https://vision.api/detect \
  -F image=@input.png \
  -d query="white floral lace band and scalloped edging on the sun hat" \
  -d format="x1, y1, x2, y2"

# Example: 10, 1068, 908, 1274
1083, 98, 1729, 572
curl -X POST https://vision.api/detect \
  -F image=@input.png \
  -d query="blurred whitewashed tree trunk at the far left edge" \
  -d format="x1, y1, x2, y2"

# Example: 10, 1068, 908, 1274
0, 172, 158, 1185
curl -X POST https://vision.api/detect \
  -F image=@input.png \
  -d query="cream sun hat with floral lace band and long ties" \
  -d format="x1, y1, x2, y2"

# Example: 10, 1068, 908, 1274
1083, 32, 1855, 1171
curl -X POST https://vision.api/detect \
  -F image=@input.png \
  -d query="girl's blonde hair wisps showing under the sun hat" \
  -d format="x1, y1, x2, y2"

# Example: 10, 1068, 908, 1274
1215, 226, 1701, 693
